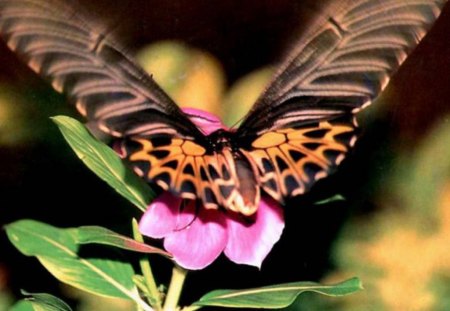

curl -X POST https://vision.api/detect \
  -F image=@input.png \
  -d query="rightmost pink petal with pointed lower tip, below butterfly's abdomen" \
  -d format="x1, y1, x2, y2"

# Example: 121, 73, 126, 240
224, 196, 284, 268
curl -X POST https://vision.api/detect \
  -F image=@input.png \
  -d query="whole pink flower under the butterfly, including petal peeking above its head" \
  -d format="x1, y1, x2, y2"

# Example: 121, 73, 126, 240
139, 109, 284, 270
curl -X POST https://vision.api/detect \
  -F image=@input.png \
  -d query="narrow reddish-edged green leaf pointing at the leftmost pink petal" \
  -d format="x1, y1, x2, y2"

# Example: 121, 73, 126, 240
73, 226, 172, 258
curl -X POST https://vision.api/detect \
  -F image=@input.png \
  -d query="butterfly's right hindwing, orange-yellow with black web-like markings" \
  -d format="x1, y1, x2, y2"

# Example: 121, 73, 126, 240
242, 118, 356, 201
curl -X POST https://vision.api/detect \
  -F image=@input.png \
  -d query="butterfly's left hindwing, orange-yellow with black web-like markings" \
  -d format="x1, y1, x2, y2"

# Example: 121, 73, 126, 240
121, 135, 256, 213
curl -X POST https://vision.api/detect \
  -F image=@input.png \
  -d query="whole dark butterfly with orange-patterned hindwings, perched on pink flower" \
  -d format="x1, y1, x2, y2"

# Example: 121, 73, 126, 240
0, 0, 446, 215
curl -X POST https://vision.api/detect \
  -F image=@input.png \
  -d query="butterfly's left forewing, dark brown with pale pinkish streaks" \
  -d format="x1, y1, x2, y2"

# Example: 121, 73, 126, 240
0, 0, 202, 140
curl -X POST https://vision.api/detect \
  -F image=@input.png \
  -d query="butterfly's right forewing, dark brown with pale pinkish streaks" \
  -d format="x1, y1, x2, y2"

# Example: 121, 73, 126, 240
238, 0, 446, 136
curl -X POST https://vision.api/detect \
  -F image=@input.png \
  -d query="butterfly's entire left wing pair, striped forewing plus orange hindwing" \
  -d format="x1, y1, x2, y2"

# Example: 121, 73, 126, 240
0, 0, 239, 207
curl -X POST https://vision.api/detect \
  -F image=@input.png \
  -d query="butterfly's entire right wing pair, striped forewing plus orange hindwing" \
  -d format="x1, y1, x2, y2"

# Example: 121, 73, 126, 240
237, 0, 446, 201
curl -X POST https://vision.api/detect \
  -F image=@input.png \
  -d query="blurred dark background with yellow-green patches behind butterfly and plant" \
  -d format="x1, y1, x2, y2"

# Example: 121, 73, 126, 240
0, 0, 450, 310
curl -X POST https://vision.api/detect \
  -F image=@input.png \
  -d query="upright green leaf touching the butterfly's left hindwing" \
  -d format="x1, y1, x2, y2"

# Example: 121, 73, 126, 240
52, 116, 154, 211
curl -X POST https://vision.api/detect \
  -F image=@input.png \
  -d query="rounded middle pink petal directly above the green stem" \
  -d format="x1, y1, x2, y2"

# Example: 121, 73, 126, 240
164, 201, 228, 270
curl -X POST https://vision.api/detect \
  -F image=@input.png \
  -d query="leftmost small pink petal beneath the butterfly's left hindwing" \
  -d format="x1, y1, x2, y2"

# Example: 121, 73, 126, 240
139, 191, 195, 239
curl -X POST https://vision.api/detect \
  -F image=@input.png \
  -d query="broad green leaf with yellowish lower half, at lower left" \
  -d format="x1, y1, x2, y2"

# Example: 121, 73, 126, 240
5, 220, 149, 310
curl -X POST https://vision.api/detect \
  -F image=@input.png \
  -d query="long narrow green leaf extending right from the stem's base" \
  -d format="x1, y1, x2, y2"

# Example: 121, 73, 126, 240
193, 278, 362, 309
